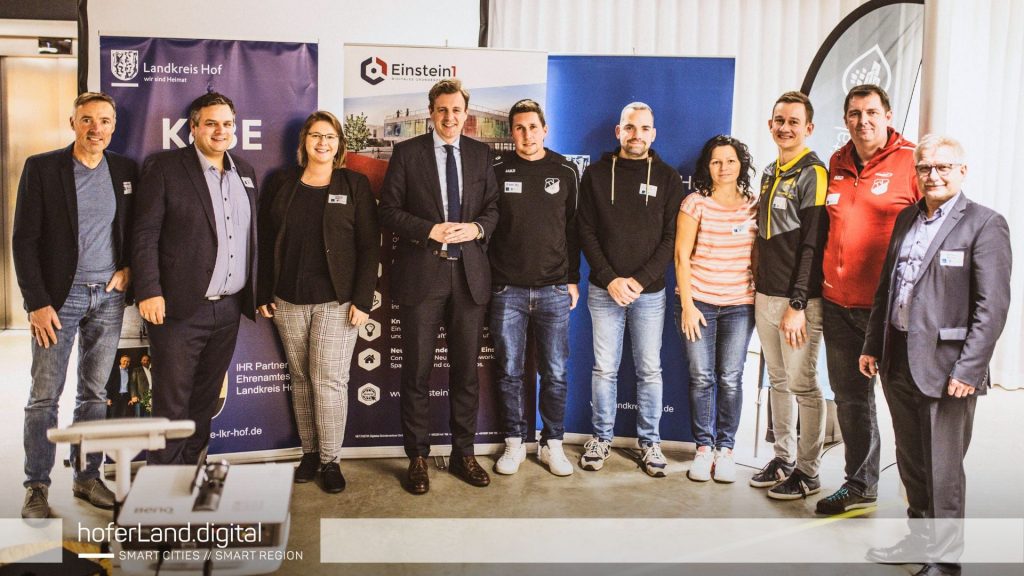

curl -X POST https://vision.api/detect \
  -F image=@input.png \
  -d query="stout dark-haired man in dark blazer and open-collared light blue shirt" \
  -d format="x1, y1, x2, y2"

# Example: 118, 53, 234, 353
132, 92, 257, 464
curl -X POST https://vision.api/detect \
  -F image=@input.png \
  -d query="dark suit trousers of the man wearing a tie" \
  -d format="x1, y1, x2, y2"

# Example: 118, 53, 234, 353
399, 260, 486, 458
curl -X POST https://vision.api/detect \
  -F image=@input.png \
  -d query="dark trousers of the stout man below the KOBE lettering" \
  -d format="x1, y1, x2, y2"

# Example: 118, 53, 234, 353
147, 295, 242, 464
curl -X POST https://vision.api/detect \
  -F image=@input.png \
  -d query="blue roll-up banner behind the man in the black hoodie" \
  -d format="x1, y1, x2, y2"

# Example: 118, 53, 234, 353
547, 55, 735, 442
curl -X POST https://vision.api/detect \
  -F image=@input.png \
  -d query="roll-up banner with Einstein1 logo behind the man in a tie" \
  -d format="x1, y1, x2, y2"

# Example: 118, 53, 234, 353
343, 45, 547, 455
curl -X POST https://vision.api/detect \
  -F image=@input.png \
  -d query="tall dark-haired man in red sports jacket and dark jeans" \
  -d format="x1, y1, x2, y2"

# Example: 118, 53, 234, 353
815, 84, 921, 515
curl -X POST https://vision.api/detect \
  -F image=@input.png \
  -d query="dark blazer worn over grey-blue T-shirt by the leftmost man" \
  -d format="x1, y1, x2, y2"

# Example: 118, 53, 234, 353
11, 145, 138, 312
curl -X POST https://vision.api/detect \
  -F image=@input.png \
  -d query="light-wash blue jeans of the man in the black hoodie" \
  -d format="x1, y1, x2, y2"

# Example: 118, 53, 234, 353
587, 284, 665, 447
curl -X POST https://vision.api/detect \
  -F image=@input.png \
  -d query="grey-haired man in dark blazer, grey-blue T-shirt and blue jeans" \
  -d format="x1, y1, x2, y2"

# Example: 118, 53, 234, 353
11, 92, 138, 518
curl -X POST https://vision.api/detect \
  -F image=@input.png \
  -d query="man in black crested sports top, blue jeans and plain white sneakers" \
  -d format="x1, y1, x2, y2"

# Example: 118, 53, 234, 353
488, 99, 580, 476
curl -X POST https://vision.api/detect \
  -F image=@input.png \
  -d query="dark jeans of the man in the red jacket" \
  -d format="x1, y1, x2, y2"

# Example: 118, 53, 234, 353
822, 299, 879, 497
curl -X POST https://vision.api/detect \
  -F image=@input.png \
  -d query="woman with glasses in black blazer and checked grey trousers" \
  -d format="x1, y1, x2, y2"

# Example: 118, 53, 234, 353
257, 111, 380, 493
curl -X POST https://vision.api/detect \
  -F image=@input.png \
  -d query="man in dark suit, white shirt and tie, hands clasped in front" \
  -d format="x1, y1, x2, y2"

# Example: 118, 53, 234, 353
380, 79, 498, 494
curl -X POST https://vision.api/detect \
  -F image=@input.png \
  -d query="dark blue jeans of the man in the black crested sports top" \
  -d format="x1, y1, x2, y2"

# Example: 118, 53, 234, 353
490, 284, 571, 444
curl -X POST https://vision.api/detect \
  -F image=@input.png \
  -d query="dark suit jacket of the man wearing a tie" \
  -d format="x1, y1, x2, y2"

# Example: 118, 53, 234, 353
380, 132, 498, 304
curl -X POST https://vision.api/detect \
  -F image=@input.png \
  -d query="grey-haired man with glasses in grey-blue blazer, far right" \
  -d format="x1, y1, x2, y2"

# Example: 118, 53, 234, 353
860, 134, 1011, 576
